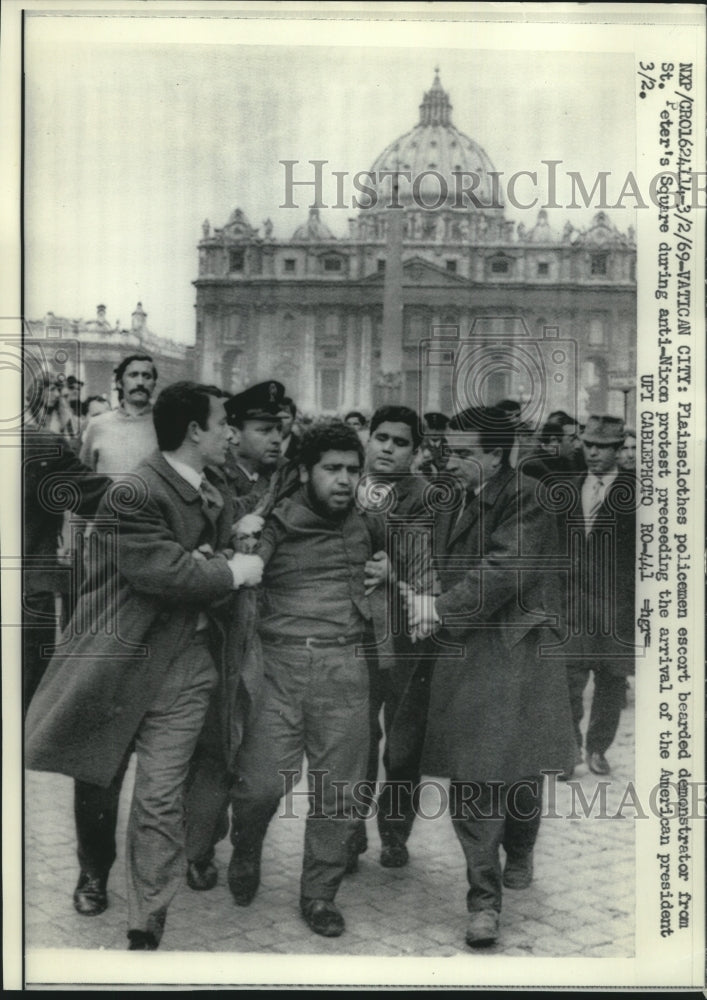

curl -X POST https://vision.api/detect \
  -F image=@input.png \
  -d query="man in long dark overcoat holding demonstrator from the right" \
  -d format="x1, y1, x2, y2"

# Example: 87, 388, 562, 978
408, 407, 572, 947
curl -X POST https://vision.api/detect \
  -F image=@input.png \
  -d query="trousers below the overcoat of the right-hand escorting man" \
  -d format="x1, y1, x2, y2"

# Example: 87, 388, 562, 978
449, 776, 543, 913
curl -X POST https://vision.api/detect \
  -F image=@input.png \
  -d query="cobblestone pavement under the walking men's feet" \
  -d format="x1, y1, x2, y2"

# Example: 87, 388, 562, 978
25, 685, 635, 958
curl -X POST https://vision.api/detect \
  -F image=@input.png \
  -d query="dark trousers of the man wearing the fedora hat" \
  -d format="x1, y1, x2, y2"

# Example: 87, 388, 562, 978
567, 661, 626, 754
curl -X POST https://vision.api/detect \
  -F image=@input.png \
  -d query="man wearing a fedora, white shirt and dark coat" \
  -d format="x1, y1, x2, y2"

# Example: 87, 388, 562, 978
563, 416, 636, 778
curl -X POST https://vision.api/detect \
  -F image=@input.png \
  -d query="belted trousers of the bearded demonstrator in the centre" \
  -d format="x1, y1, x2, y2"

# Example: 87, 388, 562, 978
231, 643, 369, 900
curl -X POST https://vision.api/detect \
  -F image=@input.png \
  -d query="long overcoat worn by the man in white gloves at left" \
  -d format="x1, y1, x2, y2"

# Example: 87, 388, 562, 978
25, 452, 233, 786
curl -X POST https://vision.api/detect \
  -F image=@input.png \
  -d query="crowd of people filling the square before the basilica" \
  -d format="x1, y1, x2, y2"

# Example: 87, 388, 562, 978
23, 354, 635, 950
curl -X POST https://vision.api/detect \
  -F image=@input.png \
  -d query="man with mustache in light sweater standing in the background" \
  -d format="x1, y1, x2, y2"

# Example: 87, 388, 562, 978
79, 354, 157, 476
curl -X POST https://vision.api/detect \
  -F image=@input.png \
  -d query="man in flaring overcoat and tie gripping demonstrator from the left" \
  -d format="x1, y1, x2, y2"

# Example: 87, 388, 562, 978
25, 382, 262, 950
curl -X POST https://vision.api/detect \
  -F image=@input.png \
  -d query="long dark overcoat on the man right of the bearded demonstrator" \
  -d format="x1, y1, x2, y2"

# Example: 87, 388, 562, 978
422, 468, 573, 782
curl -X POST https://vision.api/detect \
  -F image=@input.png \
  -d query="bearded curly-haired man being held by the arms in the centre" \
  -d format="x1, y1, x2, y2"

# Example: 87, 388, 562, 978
228, 421, 388, 937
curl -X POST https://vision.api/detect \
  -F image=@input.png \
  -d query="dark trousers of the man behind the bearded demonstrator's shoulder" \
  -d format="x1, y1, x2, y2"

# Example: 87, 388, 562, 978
358, 640, 434, 846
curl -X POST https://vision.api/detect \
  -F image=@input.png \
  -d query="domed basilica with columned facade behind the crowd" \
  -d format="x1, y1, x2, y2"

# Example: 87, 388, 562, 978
194, 75, 636, 422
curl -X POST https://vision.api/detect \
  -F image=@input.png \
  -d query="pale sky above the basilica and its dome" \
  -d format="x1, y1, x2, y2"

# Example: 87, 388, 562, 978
24, 8, 635, 344
